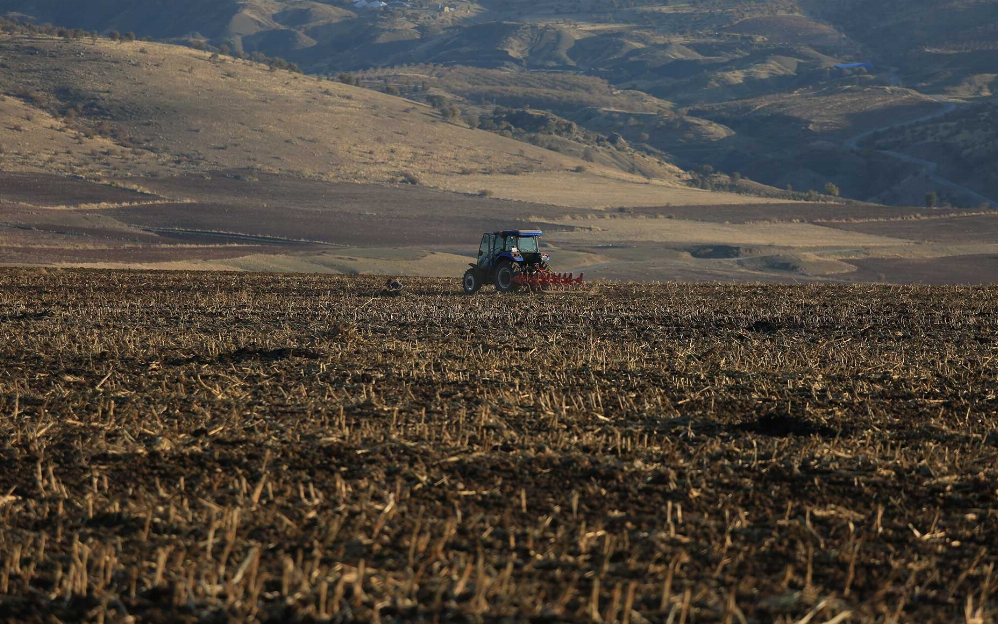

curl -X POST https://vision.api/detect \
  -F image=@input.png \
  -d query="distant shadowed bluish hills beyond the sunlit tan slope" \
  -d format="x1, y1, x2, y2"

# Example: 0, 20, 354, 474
7, 0, 998, 205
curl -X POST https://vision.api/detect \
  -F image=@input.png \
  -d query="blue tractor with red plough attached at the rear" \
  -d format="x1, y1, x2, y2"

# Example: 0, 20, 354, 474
463, 230, 582, 295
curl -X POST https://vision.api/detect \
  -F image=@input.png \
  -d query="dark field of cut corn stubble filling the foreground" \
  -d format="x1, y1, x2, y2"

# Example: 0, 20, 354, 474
0, 270, 998, 624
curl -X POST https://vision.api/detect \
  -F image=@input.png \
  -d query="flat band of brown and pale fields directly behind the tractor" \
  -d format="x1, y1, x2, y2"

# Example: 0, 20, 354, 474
7, 167, 998, 282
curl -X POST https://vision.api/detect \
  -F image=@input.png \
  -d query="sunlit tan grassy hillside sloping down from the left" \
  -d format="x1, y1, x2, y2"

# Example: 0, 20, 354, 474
0, 36, 728, 205
